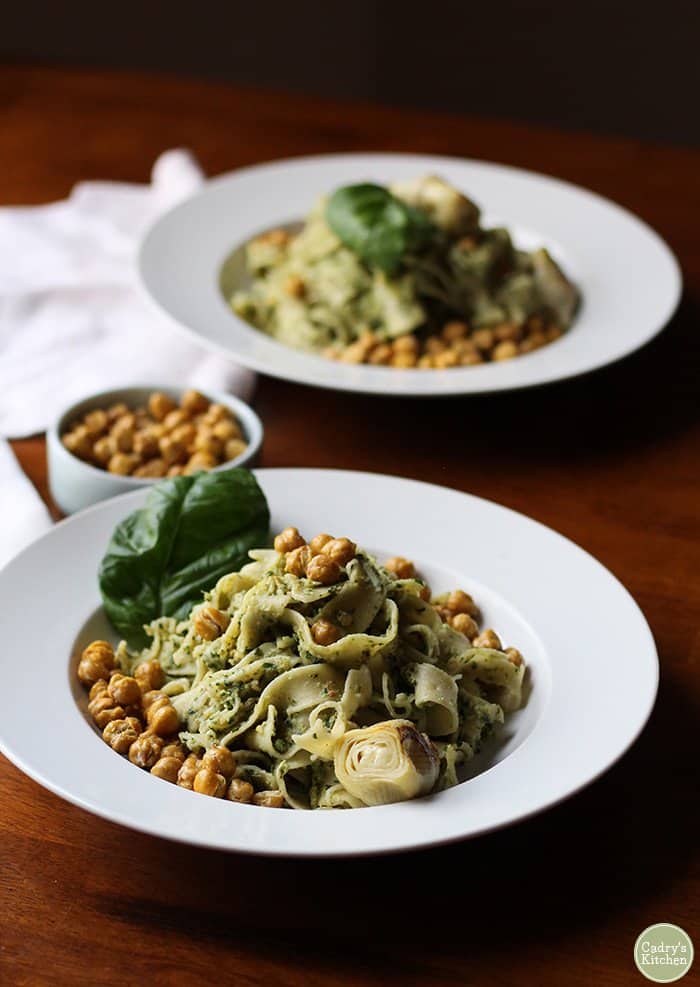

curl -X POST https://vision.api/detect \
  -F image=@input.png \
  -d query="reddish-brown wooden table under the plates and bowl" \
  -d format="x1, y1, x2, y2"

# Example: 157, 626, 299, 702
0, 68, 700, 987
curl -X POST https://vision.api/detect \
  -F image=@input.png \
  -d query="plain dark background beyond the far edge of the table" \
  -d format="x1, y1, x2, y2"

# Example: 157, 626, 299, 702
0, 0, 700, 144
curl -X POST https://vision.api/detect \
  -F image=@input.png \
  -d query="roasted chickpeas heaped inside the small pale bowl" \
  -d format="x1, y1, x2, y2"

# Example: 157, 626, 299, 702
61, 390, 248, 479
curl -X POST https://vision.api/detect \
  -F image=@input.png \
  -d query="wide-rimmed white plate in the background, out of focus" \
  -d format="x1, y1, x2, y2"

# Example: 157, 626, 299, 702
139, 154, 681, 396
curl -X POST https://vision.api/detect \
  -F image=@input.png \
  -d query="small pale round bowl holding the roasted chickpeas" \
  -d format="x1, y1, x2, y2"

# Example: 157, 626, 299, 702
46, 384, 263, 514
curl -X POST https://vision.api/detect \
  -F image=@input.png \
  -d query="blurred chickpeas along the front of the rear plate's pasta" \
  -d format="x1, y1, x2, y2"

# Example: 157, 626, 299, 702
323, 315, 562, 370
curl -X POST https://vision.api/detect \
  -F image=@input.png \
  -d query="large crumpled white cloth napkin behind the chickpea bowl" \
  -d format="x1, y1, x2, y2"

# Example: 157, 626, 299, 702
0, 150, 255, 438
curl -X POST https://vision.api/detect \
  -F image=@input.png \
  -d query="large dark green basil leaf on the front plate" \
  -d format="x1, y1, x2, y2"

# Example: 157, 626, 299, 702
99, 468, 270, 648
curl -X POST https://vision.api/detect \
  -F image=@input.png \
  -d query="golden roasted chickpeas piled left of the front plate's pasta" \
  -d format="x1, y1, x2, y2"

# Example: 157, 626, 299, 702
78, 640, 284, 809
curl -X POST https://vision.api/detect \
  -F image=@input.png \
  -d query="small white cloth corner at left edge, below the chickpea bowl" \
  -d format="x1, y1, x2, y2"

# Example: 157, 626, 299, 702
0, 439, 52, 568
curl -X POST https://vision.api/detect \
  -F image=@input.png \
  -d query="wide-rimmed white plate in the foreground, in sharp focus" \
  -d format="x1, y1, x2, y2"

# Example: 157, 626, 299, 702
0, 469, 658, 855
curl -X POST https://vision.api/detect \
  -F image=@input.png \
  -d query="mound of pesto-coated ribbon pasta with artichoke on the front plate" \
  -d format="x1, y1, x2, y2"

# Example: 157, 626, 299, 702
97, 529, 525, 809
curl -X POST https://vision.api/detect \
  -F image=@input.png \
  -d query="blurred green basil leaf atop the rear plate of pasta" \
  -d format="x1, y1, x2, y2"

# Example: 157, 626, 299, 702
326, 183, 433, 274
